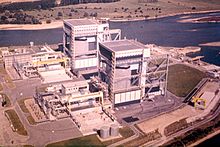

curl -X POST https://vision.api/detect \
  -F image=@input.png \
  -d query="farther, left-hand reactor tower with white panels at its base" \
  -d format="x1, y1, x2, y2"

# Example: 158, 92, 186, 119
63, 19, 121, 74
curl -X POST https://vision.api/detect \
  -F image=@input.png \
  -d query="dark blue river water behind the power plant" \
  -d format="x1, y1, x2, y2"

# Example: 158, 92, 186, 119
0, 12, 220, 65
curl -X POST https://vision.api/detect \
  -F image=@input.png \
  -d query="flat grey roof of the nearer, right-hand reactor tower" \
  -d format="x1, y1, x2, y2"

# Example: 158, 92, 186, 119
101, 39, 146, 52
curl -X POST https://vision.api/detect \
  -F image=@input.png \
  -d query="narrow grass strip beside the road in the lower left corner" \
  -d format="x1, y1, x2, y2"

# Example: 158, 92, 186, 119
5, 109, 27, 136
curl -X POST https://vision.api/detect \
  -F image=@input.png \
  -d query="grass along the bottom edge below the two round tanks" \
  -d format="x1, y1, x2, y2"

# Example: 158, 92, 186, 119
47, 127, 134, 147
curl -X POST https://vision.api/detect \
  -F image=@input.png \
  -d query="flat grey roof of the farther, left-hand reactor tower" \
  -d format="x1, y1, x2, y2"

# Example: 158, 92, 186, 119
64, 19, 98, 26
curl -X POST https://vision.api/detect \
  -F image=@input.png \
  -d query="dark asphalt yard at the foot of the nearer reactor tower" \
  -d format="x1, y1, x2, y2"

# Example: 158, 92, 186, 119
114, 94, 182, 124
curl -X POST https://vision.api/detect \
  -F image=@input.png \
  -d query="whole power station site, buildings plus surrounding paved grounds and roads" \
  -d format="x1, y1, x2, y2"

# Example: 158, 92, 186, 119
0, 19, 220, 146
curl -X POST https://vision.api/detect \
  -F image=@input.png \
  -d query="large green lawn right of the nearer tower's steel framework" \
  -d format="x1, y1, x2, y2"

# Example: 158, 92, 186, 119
167, 64, 205, 97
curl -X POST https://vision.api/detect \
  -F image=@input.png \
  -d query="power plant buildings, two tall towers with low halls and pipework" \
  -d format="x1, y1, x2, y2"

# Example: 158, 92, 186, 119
2, 19, 169, 132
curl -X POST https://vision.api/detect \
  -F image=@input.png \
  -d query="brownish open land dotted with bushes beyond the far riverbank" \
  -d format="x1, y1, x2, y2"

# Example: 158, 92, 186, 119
24, 0, 220, 20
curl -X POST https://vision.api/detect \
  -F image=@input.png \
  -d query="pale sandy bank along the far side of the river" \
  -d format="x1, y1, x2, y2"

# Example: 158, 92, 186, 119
0, 10, 220, 30
